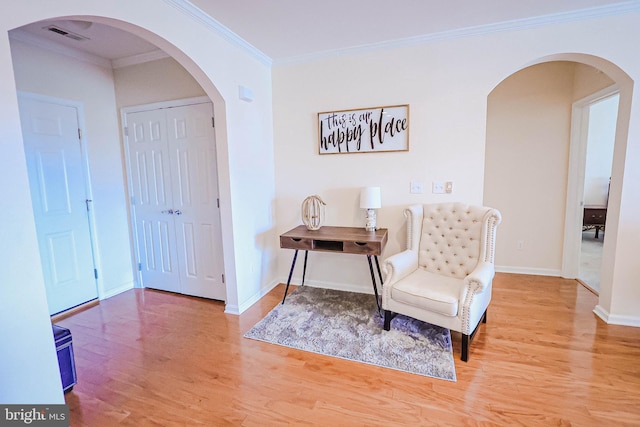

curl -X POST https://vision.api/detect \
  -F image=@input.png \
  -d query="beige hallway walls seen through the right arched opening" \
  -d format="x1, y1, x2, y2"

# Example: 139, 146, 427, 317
484, 54, 633, 318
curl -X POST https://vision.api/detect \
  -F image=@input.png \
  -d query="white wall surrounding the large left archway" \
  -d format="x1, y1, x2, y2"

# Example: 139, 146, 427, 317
0, 0, 276, 403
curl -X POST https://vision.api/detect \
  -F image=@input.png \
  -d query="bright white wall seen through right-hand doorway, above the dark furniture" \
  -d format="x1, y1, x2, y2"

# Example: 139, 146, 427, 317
584, 95, 619, 206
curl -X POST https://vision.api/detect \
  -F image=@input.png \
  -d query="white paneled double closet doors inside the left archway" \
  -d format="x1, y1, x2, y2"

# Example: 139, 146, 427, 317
126, 103, 226, 300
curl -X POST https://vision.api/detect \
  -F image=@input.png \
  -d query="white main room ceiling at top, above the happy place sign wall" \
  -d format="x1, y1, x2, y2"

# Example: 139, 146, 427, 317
191, 0, 620, 61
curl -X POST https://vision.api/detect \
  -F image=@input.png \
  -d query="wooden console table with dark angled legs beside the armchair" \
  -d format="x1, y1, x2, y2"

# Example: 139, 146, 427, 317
280, 225, 388, 311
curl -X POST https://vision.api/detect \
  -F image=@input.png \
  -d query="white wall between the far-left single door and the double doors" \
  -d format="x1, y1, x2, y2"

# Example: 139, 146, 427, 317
11, 41, 133, 296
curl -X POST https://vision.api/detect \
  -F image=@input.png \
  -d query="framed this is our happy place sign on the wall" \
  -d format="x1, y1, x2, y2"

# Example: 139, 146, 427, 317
318, 105, 409, 154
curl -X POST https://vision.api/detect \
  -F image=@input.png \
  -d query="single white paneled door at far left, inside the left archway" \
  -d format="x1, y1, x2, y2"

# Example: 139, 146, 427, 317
19, 95, 98, 314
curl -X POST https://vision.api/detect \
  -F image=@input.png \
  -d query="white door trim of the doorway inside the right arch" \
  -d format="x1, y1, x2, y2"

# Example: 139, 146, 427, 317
562, 85, 620, 279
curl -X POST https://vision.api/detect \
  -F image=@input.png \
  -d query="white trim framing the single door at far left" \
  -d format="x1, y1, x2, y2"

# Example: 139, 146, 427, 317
16, 90, 107, 300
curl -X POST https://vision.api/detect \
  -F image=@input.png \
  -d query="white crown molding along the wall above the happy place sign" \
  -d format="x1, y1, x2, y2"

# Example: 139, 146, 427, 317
273, 0, 640, 66
